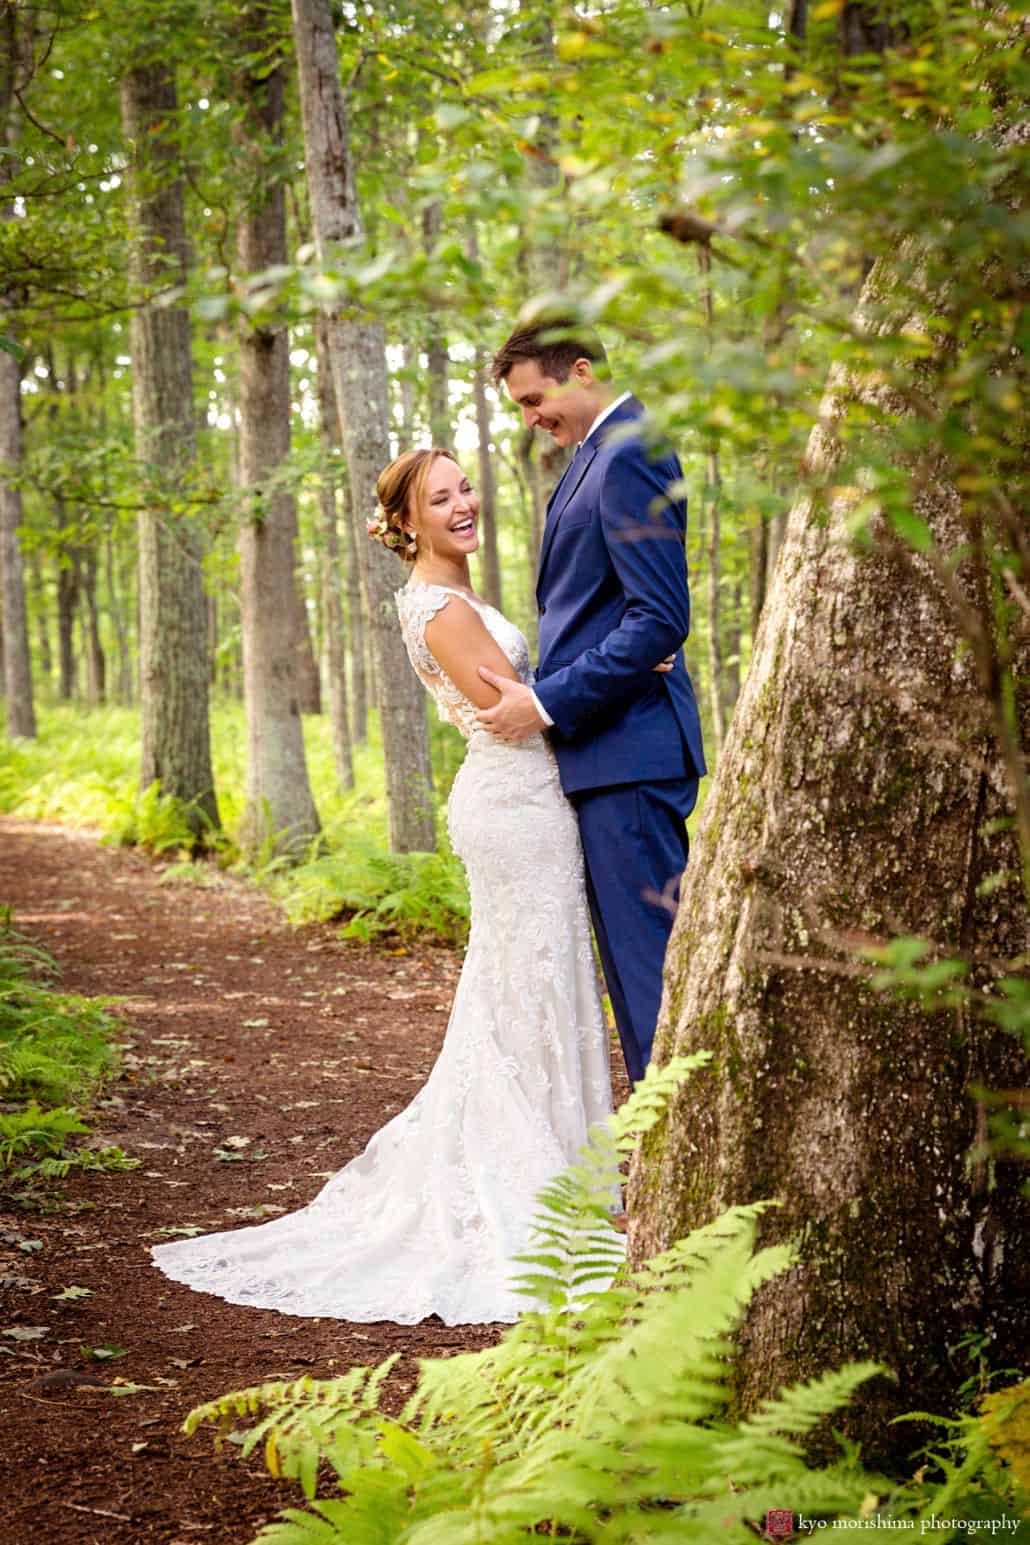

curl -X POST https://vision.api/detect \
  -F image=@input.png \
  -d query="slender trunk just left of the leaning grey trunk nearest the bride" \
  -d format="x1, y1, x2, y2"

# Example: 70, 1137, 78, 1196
315, 317, 354, 789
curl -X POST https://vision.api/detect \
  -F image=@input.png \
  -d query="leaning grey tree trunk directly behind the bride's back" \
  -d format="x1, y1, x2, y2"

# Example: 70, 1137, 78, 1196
293, 0, 435, 853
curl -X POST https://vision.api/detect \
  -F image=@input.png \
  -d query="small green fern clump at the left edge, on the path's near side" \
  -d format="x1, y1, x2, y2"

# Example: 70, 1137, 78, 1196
0, 908, 136, 1182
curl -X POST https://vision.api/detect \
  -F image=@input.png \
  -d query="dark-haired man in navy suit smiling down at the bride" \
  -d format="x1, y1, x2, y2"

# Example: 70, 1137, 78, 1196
479, 320, 704, 1080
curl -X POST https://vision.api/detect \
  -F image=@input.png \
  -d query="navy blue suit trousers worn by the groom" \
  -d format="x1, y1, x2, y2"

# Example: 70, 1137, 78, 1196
570, 776, 698, 1083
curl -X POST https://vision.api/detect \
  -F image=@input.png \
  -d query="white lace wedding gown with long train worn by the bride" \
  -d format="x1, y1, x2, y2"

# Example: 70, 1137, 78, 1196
151, 581, 612, 1326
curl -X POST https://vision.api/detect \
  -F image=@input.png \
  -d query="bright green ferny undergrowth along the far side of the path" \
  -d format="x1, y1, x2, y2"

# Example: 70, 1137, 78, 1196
0, 701, 468, 942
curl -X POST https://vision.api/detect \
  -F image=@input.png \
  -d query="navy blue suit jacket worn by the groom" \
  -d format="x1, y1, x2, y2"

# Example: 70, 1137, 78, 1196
536, 397, 704, 794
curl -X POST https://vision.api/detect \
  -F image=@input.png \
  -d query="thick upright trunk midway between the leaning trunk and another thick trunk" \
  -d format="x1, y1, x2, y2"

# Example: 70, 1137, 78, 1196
236, 12, 320, 856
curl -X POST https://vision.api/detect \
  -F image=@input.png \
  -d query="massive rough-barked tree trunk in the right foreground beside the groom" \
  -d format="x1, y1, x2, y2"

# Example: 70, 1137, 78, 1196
630, 265, 1030, 1462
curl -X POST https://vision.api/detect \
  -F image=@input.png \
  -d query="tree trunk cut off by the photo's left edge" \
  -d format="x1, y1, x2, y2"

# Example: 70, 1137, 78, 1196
0, 5, 36, 737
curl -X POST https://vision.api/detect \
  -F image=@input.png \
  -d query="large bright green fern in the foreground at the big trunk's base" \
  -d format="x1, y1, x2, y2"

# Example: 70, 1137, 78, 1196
185, 1054, 945, 1545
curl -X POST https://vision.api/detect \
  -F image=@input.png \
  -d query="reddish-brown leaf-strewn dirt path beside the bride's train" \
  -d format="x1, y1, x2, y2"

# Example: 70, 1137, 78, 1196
0, 819, 531, 1545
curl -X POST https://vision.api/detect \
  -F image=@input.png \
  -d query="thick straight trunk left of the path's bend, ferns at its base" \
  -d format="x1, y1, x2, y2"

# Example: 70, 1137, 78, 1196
122, 63, 218, 834
